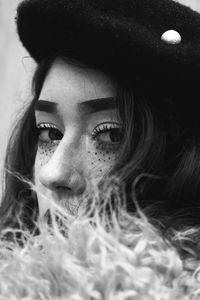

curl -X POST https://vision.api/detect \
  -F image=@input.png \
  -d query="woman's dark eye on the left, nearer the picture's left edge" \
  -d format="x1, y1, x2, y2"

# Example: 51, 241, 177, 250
37, 123, 63, 143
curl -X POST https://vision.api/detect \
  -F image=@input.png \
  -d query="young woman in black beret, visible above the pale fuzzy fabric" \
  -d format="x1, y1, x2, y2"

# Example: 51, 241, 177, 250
0, 0, 200, 239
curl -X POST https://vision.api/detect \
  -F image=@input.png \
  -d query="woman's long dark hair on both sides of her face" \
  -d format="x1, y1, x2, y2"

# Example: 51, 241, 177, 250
0, 57, 200, 239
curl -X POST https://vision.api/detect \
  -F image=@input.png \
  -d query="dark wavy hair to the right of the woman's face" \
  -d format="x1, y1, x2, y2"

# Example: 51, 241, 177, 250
116, 82, 200, 232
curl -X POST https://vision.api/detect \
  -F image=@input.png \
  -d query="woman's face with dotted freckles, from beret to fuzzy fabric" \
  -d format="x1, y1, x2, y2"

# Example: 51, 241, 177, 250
34, 59, 121, 216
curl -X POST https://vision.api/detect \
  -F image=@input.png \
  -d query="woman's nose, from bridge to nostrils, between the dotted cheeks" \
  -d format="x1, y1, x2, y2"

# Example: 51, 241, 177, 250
39, 134, 86, 196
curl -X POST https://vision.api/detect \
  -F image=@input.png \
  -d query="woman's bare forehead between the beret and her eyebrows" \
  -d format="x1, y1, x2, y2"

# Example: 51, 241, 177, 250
39, 58, 116, 102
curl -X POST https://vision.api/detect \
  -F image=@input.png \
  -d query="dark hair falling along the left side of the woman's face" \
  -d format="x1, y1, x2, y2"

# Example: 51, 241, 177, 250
0, 58, 54, 231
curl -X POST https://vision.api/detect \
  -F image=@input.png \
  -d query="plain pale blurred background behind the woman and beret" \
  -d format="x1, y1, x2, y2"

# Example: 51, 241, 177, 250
0, 0, 200, 195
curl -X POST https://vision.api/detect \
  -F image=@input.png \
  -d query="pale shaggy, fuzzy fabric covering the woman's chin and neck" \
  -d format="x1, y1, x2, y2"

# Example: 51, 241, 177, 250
0, 197, 200, 300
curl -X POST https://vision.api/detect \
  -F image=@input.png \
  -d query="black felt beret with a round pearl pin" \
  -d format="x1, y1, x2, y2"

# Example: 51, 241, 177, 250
16, 0, 200, 133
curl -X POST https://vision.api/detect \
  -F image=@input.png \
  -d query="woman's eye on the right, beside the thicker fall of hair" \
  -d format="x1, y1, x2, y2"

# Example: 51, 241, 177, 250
92, 123, 123, 150
